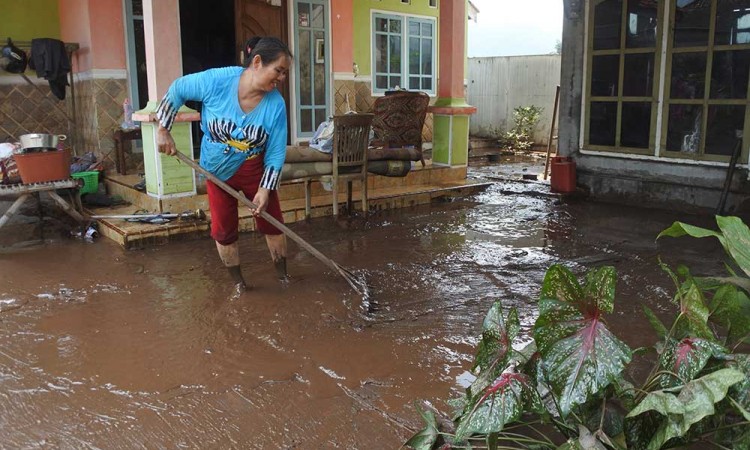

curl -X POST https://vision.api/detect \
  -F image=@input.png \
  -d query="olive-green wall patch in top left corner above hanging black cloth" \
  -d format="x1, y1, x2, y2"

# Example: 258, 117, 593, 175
0, 0, 60, 44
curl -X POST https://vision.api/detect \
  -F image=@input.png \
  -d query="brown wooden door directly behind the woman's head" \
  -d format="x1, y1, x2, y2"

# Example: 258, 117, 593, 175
234, 0, 293, 138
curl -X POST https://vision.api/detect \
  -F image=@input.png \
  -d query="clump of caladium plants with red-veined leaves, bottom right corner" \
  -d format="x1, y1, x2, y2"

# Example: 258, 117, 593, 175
407, 217, 750, 450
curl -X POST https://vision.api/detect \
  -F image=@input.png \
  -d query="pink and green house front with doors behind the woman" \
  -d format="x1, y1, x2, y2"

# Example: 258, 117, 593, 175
0, 0, 477, 185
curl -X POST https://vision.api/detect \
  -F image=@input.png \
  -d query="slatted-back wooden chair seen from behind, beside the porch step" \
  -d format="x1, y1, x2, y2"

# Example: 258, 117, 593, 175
331, 114, 373, 217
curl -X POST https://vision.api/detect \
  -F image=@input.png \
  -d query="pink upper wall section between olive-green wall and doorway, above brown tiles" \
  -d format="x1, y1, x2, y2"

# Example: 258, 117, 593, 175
58, 0, 125, 72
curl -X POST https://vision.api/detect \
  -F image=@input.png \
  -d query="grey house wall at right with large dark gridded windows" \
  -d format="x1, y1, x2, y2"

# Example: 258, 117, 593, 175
559, 0, 750, 210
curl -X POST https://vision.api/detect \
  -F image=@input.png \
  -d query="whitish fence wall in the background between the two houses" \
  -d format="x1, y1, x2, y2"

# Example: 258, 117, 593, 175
466, 55, 560, 145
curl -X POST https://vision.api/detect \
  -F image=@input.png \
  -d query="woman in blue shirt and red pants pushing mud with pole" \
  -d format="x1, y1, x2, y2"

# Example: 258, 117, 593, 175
156, 37, 292, 294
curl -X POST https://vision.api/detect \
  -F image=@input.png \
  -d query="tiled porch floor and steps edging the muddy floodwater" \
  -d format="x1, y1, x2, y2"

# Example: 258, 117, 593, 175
87, 164, 488, 248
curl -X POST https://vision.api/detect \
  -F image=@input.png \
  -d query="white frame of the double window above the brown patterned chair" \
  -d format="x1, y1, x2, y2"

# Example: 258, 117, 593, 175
370, 11, 438, 96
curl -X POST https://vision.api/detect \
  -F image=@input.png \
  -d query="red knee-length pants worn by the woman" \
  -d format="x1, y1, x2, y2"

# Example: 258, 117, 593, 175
206, 157, 284, 245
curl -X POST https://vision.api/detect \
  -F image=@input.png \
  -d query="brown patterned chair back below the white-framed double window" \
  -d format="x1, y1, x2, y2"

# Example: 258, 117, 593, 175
372, 92, 430, 166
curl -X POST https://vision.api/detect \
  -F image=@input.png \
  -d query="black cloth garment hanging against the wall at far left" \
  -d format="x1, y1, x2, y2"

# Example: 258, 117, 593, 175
29, 38, 70, 100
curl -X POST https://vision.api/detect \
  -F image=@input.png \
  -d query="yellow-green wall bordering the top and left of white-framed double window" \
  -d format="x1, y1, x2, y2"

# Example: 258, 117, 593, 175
354, 0, 440, 77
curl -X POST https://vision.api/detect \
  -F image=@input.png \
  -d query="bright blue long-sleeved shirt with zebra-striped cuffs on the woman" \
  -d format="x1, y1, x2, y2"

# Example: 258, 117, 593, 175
156, 67, 287, 189
